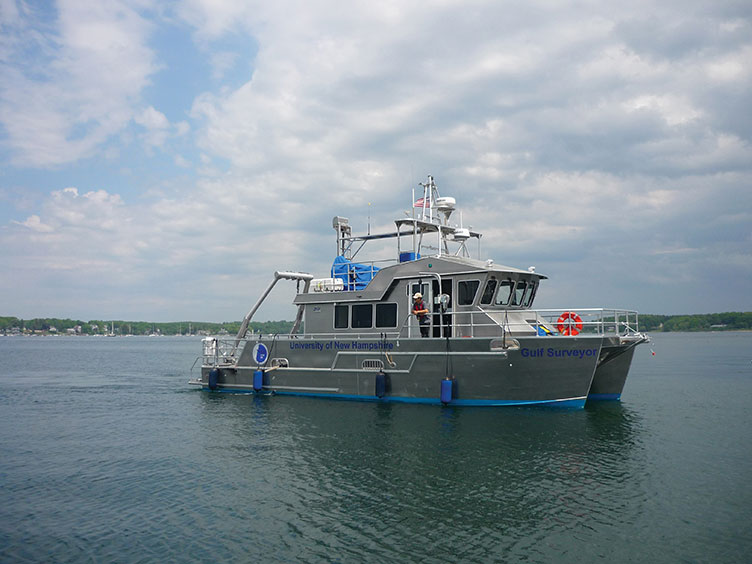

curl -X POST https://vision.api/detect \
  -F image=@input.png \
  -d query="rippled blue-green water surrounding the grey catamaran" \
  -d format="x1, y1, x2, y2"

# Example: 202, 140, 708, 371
0, 333, 752, 562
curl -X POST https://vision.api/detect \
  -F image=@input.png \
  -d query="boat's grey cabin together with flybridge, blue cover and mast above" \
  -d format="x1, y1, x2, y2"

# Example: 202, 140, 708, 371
294, 176, 546, 337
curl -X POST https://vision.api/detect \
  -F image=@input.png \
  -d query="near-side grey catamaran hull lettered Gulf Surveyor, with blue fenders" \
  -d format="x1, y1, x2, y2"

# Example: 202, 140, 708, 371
194, 337, 602, 407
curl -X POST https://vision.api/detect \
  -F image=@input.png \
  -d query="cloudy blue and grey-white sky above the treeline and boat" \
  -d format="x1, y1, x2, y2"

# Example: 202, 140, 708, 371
0, 0, 752, 321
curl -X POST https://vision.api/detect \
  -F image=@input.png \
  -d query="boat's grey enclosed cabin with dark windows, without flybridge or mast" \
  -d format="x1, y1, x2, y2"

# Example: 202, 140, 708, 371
294, 256, 545, 337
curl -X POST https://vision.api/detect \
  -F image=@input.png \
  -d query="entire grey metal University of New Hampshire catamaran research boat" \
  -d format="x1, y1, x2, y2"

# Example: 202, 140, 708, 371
190, 176, 648, 408
